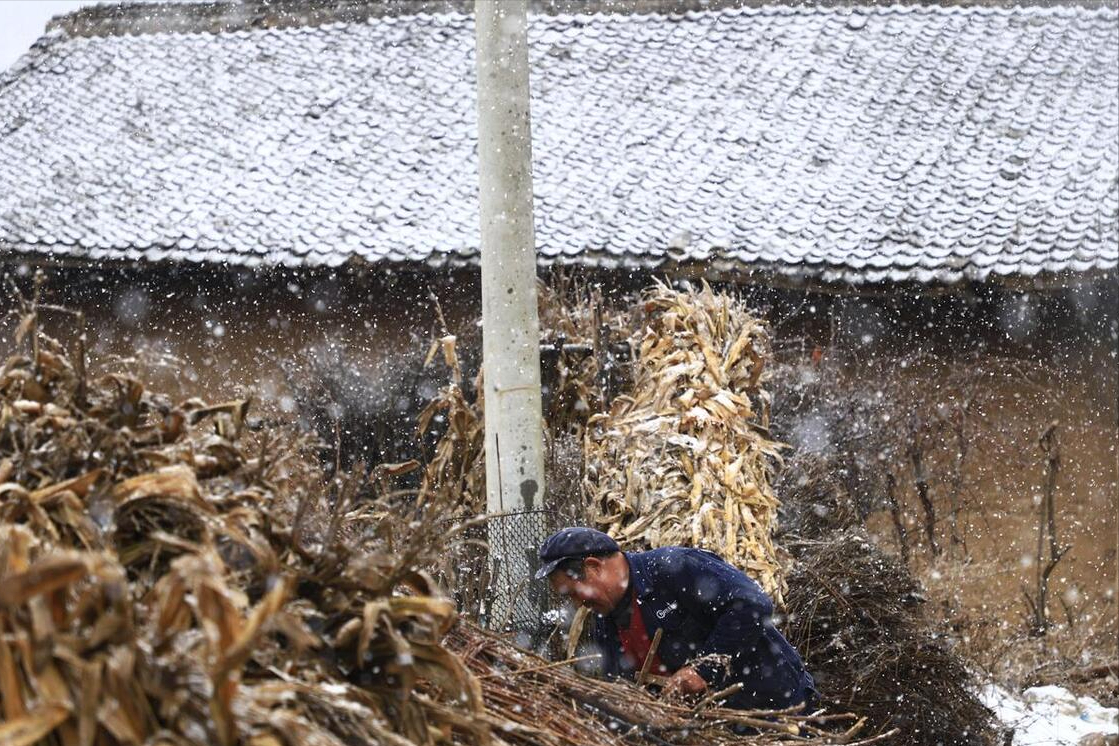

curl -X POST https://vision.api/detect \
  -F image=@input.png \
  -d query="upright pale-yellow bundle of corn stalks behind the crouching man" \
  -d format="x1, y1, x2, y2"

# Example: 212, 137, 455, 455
585, 284, 786, 604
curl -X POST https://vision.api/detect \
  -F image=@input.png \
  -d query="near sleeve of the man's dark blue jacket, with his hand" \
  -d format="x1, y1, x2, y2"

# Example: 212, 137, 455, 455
678, 550, 773, 684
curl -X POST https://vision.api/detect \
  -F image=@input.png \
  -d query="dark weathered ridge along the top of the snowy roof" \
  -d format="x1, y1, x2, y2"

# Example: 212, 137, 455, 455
39, 0, 1119, 37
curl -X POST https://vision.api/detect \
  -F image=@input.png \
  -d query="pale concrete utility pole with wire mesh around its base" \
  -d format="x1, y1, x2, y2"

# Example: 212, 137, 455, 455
474, 0, 545, 626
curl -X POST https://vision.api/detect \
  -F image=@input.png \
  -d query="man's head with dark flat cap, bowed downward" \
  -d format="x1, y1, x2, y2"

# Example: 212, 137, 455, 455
536, 527, 629, 614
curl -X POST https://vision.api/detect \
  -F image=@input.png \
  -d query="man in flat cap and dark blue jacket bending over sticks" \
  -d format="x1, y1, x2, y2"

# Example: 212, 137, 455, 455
536, 527, 817, 709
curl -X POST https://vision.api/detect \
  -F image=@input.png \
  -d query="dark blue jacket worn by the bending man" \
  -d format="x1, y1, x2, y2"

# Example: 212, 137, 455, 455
593, 547, 815, 709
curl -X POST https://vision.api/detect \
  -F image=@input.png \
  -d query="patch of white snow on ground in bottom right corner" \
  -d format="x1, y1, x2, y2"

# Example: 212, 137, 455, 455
979, 683, 1119, 746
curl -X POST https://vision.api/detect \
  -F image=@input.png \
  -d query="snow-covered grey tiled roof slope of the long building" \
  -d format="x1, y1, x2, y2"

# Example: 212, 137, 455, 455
0, 7, 1119, 283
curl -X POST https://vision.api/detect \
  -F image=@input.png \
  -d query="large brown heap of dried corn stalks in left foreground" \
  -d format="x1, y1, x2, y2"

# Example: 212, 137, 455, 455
0, 288, 500, 746
